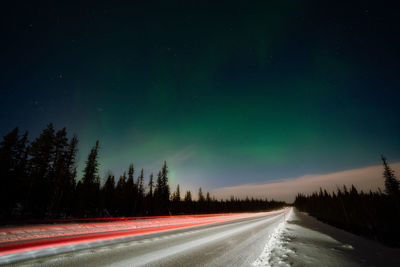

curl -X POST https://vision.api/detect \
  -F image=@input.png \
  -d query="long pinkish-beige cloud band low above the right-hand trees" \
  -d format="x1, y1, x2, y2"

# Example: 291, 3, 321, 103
211, 162, 400, 202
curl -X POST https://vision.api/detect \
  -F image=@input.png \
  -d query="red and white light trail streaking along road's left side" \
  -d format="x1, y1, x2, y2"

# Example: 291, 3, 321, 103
0, 212, 284, 256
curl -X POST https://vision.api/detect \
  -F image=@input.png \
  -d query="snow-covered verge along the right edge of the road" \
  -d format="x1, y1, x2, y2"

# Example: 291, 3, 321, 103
253, 210, 400, 266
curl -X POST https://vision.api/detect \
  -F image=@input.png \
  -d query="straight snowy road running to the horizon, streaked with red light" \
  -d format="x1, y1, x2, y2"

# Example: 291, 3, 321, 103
0, 209, 290, 266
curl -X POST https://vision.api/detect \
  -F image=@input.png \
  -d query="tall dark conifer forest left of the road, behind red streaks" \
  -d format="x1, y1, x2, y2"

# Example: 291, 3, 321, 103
0, 124, 285, 222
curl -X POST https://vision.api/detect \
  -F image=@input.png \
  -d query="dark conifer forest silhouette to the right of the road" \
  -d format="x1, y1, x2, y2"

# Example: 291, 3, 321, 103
294, 156, 400, 247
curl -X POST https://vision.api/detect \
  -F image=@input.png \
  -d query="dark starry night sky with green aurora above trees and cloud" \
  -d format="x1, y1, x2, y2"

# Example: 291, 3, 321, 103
0, 1, 400, 195
